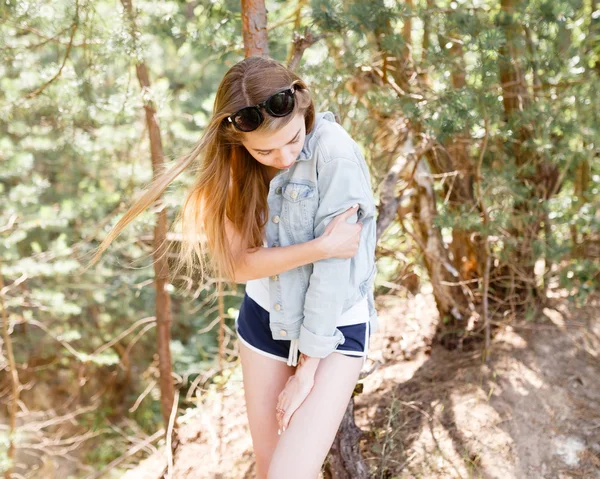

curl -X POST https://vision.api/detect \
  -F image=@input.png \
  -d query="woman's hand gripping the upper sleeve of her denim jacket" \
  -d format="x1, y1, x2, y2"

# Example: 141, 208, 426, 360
315, 206, 362, 258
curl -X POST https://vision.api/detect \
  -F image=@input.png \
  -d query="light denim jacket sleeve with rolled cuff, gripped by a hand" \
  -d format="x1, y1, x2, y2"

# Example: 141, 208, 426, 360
298, 158, 373, 358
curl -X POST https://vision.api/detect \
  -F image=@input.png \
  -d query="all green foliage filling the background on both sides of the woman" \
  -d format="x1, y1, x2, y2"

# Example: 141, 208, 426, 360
0, 0, 600, 476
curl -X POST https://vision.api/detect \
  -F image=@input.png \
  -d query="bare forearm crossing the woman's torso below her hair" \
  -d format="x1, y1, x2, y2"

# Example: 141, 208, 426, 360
235, 238, 327, 283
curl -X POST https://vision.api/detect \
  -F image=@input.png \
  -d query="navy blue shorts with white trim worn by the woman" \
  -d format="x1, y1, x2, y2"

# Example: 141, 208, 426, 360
235, 294, 370, 366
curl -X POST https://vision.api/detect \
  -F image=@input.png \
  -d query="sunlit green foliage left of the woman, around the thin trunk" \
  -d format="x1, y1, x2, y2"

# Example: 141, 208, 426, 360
0, 0, 246, 467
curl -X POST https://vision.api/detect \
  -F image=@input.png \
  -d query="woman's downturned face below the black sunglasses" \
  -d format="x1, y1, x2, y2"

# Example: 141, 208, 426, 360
242, 113, 306, 170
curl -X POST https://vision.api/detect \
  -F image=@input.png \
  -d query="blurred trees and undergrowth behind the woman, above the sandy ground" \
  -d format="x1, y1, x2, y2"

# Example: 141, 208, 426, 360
0, 0, 600, 477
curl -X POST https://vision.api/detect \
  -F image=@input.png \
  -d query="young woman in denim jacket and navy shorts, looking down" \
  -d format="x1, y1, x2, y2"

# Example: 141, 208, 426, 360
92, 56, 378, 479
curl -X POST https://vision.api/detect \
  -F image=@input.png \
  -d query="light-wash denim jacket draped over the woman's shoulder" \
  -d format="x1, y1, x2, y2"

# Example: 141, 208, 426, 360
265, 111, 378, 365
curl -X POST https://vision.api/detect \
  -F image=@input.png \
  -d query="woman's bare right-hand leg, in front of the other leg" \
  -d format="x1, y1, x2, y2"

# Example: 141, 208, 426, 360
267, 352, 363, 479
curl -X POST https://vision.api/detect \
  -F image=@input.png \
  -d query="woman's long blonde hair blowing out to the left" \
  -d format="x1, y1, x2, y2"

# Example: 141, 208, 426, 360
87, 56, 315, 284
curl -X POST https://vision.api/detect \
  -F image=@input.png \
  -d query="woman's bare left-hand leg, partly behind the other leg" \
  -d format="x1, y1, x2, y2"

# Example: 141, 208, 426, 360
238, 341, 296, 479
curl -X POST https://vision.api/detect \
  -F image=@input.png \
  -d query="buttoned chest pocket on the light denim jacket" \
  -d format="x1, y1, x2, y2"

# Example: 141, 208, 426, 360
282, 180, 319, 243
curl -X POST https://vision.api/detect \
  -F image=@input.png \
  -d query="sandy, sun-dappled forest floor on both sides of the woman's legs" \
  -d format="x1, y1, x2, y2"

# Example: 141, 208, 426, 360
123, 286, 600, 479
